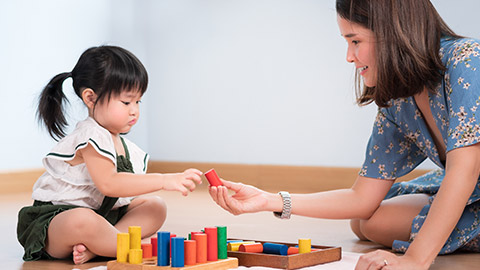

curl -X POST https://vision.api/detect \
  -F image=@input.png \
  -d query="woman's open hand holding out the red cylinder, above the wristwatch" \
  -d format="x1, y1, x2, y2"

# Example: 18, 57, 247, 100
209, 179, 268, 215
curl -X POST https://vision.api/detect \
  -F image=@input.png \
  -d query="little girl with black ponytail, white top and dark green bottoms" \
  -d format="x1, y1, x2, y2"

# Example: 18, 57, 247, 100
17, 46, 202, 264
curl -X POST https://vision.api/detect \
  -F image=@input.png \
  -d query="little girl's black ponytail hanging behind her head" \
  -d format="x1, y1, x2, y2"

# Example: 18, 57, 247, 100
37, 72, 72, 140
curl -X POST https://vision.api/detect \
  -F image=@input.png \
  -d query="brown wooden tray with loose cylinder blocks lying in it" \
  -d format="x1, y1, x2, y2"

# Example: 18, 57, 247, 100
227, 239, 342, 269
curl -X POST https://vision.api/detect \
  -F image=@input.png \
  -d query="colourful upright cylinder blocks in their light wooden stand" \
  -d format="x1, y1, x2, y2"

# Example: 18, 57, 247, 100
107, 226, 238, 270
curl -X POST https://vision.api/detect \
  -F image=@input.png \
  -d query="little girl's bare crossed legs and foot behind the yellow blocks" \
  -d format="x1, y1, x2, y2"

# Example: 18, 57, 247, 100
45, 196, 166, 264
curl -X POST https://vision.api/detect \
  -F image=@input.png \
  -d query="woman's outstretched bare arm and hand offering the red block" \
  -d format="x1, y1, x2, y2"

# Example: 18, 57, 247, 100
210, 176, 393, 219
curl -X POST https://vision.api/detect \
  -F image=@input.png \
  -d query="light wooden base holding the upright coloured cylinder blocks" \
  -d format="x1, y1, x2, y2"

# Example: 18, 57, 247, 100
107, 258, 238, 270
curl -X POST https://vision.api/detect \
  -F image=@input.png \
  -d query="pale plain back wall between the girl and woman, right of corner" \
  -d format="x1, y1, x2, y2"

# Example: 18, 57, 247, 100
141, 0, 480, 167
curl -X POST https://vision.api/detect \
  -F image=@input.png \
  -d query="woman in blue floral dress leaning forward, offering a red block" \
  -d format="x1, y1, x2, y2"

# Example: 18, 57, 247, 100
210, 0, 480, 269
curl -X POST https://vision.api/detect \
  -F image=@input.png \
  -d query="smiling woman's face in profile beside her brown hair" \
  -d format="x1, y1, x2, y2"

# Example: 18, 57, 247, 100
337, 16, 377, 87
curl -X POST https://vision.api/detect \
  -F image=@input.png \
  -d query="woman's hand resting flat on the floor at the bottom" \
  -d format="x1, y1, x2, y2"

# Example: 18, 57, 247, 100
355, 250, 428, 270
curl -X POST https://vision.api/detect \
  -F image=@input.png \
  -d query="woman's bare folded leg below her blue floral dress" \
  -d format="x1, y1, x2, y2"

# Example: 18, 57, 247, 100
350, 194, 430, 247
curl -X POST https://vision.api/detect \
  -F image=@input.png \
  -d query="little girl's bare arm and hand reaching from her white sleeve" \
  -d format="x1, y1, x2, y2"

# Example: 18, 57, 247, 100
79, 144, 202, 197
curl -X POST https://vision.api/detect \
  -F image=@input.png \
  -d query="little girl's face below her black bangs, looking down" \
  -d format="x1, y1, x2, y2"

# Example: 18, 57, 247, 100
92, 91, 142, 135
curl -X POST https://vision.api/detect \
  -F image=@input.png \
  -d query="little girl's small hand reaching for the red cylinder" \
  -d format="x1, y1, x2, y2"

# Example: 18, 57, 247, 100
162, 169, 202, 196
